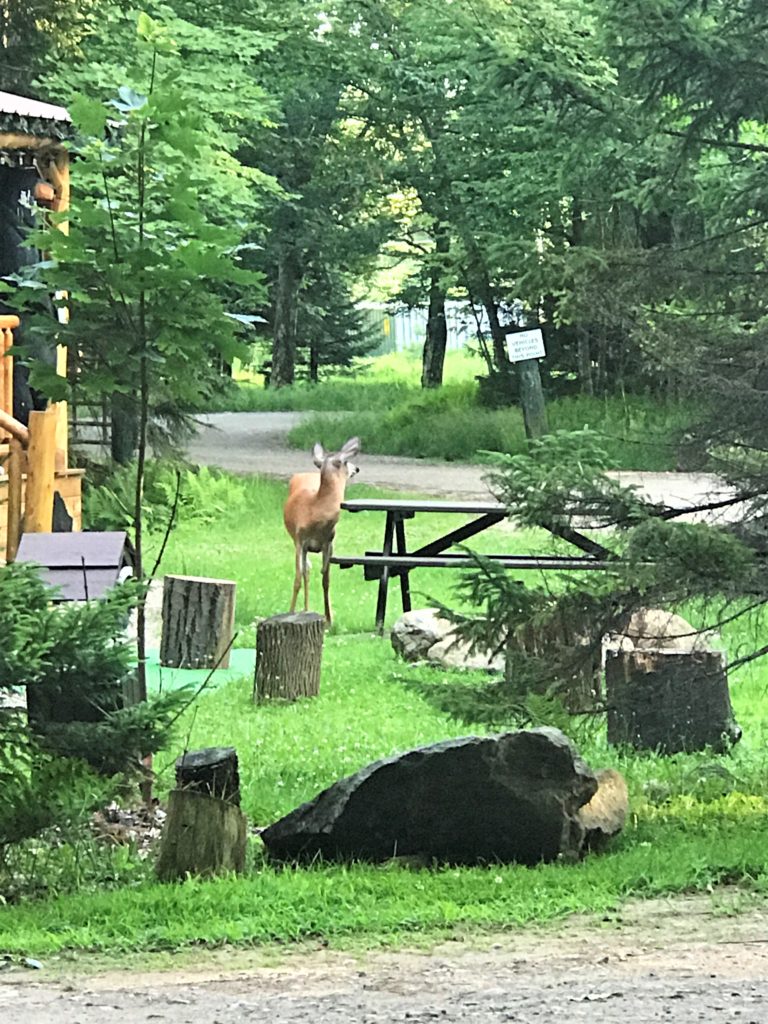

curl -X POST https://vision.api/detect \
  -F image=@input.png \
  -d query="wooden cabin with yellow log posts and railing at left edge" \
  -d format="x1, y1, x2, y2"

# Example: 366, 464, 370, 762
0, 92, 83, 562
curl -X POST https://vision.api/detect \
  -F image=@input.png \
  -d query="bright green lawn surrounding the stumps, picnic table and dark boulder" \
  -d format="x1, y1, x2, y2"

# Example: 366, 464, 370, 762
0, 468, 768, 955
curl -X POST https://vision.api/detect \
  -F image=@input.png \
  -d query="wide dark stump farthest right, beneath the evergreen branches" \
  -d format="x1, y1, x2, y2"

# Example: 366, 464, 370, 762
605, 650, 741, 754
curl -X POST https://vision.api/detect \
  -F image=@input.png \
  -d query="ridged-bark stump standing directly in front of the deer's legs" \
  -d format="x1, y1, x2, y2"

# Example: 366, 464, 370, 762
253, 611, 326, 700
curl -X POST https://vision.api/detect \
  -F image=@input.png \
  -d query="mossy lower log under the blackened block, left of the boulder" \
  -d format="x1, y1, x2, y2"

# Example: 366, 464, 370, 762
156, 790, 246, 882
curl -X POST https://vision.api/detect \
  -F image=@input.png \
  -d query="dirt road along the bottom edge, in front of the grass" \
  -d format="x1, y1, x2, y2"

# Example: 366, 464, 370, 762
0, 898, 768, 1024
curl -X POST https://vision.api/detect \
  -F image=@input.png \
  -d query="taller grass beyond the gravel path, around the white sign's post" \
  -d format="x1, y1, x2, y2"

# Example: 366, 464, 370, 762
207, 352, 693, 471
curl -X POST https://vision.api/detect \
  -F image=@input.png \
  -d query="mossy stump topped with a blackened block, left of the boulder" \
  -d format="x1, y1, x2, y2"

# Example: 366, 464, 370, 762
157, 746, 246, 882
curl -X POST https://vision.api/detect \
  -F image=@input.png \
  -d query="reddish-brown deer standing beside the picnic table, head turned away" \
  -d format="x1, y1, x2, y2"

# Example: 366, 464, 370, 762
283, 437, 360, 627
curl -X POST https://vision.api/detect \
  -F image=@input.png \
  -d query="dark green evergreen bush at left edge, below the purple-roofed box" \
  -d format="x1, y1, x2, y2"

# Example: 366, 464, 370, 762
0, 564, 187, 864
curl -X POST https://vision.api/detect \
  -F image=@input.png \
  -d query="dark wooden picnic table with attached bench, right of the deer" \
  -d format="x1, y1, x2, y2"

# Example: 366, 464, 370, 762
331, 499, 615, 633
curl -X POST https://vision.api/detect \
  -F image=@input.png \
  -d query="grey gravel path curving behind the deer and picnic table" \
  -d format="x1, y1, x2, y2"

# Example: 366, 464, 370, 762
187, 413, 741, 516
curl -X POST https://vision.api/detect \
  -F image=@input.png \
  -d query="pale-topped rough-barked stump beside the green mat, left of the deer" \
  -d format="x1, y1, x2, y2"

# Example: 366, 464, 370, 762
160, 575, 236, 669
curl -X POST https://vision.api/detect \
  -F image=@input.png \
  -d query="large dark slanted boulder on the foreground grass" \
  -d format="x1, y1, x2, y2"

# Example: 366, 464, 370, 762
261, 728, 597, 864
